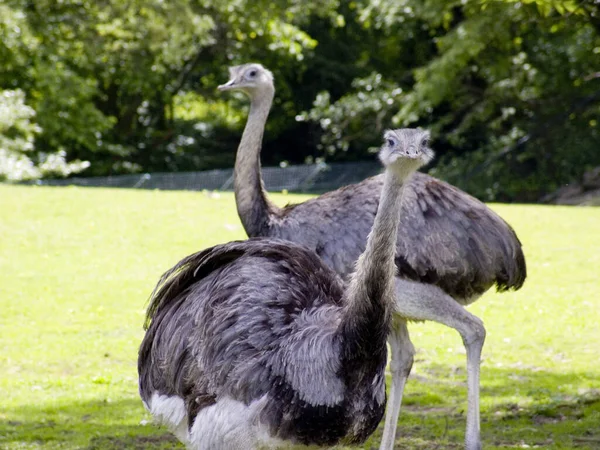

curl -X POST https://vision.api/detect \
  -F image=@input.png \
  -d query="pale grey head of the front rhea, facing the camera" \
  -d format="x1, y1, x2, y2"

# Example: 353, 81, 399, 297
379, 128, 434, 170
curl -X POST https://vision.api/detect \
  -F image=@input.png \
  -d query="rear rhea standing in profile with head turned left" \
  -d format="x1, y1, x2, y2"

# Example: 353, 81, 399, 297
219, 64, 526, 450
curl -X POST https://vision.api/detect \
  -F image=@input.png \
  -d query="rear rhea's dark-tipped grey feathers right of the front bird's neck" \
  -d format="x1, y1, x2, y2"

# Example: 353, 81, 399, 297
396, 173, 527, 298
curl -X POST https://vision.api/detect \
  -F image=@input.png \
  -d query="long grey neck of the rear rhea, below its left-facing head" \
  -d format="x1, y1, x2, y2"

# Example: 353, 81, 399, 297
233, 87, 278, 237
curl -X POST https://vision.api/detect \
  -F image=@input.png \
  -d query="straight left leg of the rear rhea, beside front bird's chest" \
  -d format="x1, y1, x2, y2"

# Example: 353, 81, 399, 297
379, 316, 415, 450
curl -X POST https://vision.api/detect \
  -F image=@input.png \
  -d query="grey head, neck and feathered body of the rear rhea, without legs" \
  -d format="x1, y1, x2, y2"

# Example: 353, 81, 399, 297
221, 64, 526, 300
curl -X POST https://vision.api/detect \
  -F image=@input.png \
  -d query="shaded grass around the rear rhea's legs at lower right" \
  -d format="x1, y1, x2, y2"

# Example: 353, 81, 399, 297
386, 365, 600, 449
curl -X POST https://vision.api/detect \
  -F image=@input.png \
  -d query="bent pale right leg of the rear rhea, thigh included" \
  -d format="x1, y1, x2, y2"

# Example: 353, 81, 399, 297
396, 279, 485, 450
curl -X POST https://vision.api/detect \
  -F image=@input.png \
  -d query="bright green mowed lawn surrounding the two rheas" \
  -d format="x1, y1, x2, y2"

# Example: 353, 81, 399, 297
0, 185, 600, 449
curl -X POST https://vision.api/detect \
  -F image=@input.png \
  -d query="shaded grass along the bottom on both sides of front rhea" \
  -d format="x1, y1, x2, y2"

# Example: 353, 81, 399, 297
0, 365, 600, 450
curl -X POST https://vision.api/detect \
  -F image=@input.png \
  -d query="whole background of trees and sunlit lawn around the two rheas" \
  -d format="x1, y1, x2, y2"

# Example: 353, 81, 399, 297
0, 0, 600, 450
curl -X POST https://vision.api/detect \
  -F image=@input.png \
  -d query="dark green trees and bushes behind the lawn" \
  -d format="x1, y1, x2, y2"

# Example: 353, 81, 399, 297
0, 0, 600, 201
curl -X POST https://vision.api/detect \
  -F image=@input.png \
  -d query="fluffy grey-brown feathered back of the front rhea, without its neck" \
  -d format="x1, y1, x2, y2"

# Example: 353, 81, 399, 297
138, 239, 378, 445
